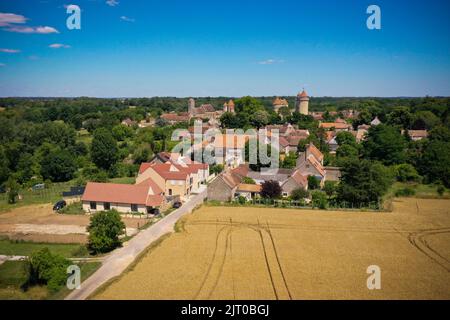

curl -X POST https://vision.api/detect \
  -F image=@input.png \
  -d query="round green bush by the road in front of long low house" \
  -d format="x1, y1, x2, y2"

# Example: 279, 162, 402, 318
87, 210, 125, 254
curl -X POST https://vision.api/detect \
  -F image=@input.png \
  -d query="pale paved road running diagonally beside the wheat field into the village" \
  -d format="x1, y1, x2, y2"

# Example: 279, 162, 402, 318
65, 189, 207, 300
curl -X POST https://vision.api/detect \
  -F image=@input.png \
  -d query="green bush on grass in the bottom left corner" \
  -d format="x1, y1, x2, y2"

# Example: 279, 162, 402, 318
26, 248, 70, 292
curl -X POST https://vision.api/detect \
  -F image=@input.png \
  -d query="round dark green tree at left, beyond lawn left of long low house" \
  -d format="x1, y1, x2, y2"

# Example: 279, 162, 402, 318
41, 150, 77, 182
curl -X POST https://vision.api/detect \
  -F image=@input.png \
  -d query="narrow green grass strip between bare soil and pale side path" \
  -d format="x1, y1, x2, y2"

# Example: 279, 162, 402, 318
0, 239, 89, 258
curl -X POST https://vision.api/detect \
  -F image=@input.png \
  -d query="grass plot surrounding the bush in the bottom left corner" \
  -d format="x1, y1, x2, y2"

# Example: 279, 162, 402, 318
0, 261, 100, 300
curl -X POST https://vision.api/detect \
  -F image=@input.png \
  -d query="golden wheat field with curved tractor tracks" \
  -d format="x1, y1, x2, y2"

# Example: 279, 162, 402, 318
94, 199, 450, 299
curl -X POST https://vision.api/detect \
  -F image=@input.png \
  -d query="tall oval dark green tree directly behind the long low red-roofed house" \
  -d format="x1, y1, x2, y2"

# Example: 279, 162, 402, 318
91, 128, 118, 170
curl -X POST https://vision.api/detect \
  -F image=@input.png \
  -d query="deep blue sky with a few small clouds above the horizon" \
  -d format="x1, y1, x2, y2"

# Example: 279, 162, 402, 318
0, 0, 450, 97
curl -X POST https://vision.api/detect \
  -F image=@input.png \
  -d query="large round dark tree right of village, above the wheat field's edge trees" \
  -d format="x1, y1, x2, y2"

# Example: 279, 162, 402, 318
363, 124, 407, 165
